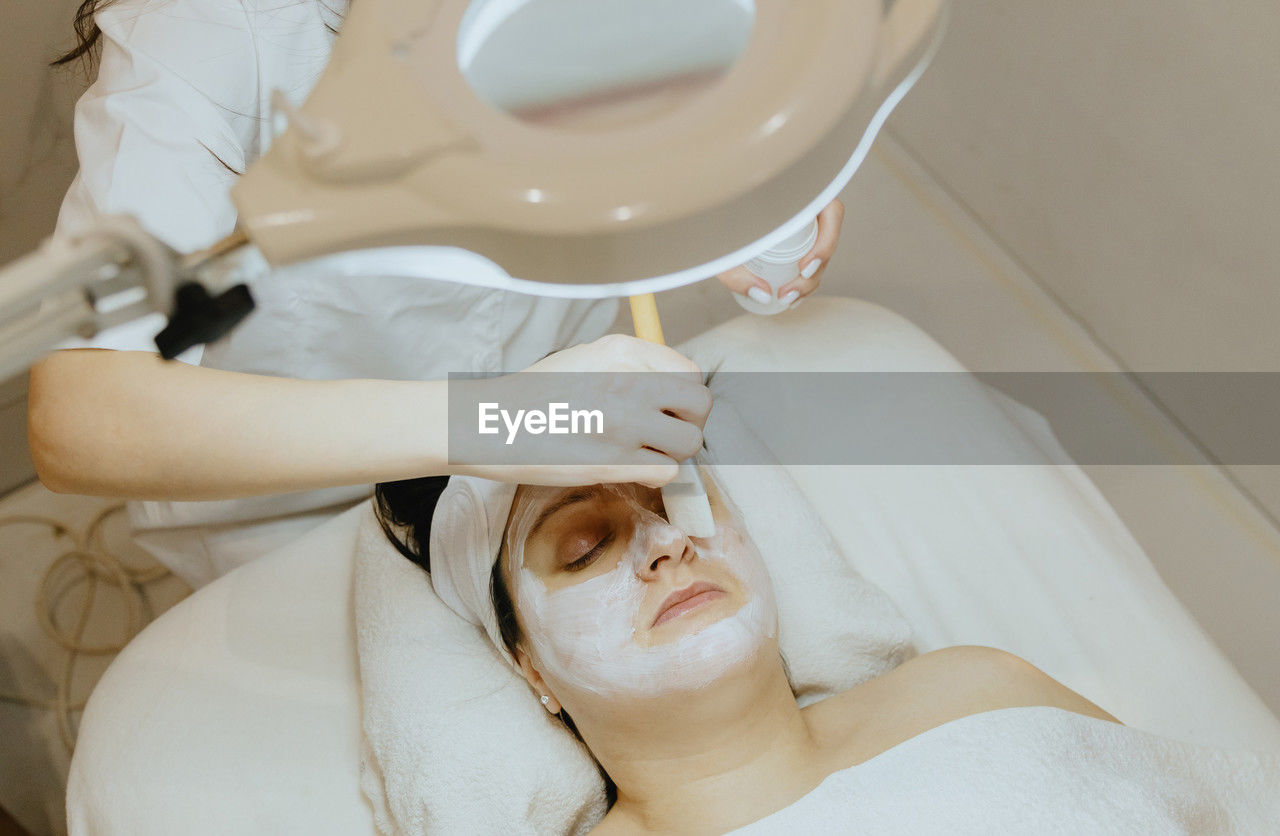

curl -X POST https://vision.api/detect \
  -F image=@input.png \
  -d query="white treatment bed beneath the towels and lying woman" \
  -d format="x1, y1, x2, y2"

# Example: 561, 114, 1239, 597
68, 300, 1280, 836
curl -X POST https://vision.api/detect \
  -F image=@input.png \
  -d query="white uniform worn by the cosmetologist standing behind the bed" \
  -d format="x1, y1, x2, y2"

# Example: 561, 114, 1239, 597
58, 0, 617, 585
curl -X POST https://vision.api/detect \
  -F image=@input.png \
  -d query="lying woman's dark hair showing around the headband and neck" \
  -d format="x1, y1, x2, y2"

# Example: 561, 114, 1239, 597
374, 476, 617, 807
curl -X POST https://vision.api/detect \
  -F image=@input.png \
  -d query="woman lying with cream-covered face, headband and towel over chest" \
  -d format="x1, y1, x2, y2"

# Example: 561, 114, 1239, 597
379, 468, 1280, 836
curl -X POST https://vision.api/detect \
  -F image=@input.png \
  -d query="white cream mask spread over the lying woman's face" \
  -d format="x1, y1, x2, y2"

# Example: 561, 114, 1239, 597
507, 478, 777, 696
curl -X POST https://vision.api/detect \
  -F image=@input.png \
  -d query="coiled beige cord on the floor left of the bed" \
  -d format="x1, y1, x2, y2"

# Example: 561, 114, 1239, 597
0, 504, 186, 754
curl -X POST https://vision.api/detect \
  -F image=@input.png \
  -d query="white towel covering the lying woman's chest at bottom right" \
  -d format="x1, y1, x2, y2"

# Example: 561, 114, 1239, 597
733, 708, 1280, 836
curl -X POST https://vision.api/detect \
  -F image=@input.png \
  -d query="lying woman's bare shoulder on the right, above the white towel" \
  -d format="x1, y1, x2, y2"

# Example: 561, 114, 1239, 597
806, 645, 1117, 763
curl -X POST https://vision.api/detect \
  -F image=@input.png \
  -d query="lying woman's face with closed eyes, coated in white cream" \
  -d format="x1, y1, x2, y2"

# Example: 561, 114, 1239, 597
504, 484, 777, 696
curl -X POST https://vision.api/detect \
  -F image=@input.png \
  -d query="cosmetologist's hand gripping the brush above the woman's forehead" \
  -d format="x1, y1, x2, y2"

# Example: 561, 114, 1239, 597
449, 334, 712, 488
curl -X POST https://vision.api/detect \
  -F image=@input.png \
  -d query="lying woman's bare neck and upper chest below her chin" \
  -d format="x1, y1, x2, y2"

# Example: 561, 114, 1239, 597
580, 652, 818, 832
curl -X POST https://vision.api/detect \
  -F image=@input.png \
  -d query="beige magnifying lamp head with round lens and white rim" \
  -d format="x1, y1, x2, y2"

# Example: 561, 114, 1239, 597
232, 0, 945, 298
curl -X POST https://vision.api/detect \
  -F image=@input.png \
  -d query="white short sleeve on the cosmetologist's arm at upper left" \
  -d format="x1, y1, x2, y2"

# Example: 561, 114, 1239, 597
56, 0, 261, 351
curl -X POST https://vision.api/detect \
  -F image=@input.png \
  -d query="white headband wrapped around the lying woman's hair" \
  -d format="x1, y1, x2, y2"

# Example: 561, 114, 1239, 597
429, 476, 517, 666
